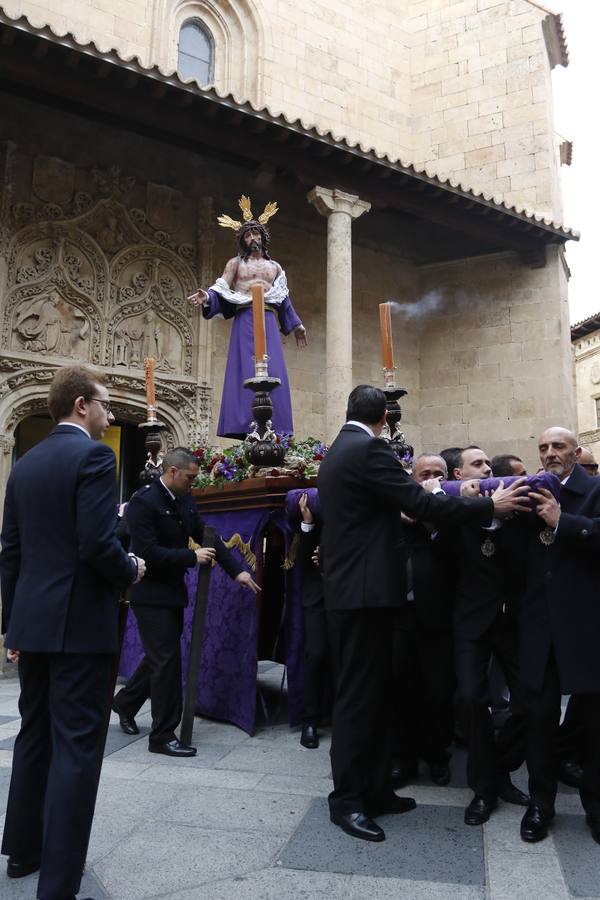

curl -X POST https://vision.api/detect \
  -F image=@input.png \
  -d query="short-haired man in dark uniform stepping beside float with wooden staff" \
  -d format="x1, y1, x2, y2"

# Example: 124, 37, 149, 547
113, 447, 259, 757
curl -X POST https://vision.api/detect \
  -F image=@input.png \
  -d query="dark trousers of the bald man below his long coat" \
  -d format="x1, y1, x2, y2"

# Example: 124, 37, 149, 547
524, 654, 600, 813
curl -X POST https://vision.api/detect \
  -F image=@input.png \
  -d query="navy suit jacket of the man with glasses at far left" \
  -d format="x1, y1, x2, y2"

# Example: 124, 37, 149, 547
0, 424, 136, 653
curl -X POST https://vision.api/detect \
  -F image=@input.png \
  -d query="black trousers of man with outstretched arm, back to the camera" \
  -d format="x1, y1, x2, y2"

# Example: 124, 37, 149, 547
327, 609, 394, 815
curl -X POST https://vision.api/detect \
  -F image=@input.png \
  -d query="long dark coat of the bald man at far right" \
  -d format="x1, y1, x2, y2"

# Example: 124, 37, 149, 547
521, 465, 600, 694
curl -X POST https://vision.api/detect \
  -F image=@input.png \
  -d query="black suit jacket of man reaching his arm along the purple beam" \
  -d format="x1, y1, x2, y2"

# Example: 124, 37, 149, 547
318, 425, 493, 610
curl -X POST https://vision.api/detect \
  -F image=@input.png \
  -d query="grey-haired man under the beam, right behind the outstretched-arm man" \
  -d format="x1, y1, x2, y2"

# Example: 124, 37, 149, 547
392, 453, 456, 787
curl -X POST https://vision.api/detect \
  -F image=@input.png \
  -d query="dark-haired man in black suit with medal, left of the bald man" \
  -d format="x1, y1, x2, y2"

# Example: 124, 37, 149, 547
454, 447, 529, 825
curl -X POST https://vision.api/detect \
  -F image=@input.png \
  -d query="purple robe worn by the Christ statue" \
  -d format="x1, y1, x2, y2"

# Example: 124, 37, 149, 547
202, 289, 302, 438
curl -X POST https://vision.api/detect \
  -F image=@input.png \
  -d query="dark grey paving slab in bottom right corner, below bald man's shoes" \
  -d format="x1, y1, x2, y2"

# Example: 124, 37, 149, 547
544, 814, 600, 898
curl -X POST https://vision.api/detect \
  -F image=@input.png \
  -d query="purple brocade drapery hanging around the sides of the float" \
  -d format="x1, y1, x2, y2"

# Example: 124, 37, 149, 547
119, 509, 304, 734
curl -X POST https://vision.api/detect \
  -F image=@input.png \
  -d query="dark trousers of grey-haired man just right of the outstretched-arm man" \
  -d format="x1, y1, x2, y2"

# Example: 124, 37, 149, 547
392, 603, 456, 765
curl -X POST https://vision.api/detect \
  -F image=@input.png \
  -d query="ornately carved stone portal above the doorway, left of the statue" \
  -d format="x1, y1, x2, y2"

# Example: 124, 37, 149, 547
0, 149, 214, 449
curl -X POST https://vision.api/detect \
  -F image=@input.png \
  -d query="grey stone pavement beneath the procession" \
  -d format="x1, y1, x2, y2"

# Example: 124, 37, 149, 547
0, 664, 600, 900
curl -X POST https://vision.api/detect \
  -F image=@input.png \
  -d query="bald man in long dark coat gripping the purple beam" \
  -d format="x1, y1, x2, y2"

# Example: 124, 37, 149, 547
520, 427, 600, 843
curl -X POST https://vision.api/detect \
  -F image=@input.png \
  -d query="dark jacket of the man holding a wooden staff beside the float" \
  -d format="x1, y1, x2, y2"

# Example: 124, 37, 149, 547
125, 478, 243, 607
